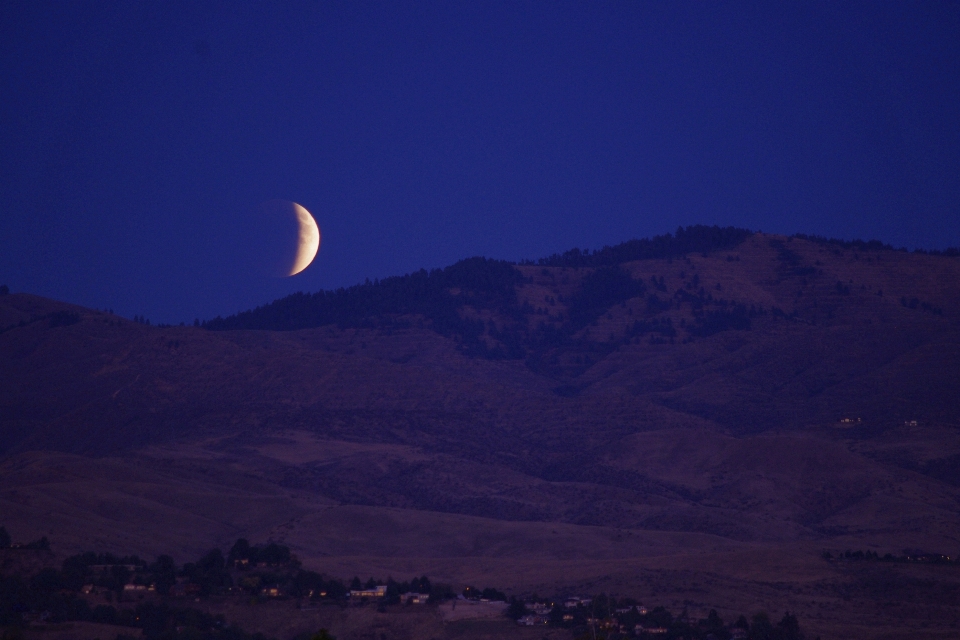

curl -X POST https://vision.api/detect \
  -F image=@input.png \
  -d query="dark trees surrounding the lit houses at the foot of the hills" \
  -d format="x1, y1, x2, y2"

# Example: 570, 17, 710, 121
0, 527, 808, 640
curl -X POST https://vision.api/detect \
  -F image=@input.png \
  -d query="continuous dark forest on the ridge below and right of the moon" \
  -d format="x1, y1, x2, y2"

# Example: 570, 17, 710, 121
202, 226, 764, 359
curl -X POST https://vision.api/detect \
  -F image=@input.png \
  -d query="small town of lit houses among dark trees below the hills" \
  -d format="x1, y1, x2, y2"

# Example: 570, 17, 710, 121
0, 527, 803, 640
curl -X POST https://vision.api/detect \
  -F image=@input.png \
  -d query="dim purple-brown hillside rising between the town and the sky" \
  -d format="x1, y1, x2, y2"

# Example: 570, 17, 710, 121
0, 228, 960, 637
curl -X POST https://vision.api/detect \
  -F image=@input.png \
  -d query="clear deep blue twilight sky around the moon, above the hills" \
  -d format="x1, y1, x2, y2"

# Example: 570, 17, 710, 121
0, 1, 960, 322
